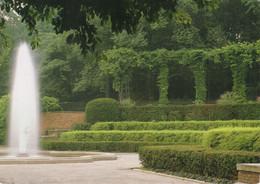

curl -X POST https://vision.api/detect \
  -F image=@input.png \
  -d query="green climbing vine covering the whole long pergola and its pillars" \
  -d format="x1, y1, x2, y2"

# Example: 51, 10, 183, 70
99, 41, 260, 104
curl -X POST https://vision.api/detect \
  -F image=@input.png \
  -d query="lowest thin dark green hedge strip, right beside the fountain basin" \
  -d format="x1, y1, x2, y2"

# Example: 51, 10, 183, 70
41, 141, 175, 152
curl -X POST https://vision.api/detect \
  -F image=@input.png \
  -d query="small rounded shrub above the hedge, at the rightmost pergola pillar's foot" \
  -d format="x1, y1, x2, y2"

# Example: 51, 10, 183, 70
217, 91, 245, 105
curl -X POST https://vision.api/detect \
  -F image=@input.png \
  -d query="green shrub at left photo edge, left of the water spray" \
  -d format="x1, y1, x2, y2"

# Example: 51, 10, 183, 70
0, 95, 10, 144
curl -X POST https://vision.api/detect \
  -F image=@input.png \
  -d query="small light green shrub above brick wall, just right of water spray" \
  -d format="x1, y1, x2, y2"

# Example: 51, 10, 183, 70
40, 96, 62, 112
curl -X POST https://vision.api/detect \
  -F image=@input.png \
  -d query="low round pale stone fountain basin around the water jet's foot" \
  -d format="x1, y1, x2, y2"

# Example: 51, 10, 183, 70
0, 151, 117, 165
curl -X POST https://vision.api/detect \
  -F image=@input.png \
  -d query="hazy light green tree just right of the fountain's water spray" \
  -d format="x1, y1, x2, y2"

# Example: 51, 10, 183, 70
38, 33, 85, 101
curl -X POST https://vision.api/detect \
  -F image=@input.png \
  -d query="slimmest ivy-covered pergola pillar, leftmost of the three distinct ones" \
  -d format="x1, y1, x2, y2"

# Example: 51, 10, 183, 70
157, 64, 169, 104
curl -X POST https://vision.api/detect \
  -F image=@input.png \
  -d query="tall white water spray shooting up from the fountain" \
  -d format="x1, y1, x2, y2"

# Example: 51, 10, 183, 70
8, 43, 39, 155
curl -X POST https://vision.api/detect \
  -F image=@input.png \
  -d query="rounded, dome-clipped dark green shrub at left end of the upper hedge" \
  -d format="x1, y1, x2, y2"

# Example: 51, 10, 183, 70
85, 98, 120, 124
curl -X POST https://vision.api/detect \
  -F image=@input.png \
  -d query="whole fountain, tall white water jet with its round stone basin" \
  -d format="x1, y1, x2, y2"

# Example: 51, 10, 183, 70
0, 43, 116, 164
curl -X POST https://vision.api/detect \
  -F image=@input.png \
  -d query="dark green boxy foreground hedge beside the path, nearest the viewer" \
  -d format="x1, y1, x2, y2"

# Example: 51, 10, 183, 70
139, 146, 260, 180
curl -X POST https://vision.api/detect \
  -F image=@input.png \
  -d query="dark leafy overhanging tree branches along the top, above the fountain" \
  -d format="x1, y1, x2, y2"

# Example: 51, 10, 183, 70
1, 0, 219, 54
